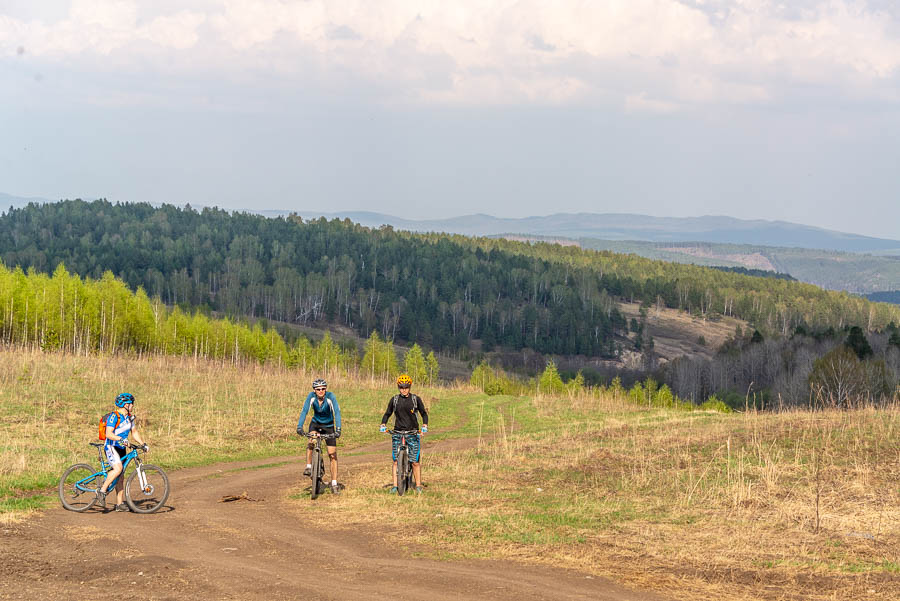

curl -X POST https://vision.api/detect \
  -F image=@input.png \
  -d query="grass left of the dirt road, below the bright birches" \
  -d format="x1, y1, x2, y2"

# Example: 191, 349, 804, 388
0, 349, 459, 519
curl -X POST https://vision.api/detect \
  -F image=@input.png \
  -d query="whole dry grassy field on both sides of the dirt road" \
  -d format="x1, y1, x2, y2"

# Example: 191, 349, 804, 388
0, 349, 900, 600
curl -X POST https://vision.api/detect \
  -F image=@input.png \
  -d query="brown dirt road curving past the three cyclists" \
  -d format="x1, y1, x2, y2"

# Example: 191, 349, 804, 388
0, 441, 662, 601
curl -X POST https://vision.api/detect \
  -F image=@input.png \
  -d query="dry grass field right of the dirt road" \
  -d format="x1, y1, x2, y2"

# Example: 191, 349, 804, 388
291, 386, 900, 600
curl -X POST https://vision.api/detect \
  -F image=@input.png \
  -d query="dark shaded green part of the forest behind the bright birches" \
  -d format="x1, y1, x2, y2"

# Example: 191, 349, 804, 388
0, 201, 625, 356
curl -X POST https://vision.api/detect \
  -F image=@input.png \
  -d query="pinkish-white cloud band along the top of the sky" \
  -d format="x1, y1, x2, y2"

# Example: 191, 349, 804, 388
0, 0, 900, 112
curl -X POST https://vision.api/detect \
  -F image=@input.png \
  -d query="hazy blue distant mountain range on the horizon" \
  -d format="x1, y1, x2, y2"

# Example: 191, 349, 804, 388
272, 211, 900, 254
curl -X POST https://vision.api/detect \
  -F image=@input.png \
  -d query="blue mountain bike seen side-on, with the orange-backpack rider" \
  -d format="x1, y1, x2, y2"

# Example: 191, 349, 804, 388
58, 442, 169, 513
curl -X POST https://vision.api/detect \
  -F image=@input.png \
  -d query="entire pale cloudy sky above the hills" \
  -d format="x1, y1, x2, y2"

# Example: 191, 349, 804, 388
0, 0, 900, 238
